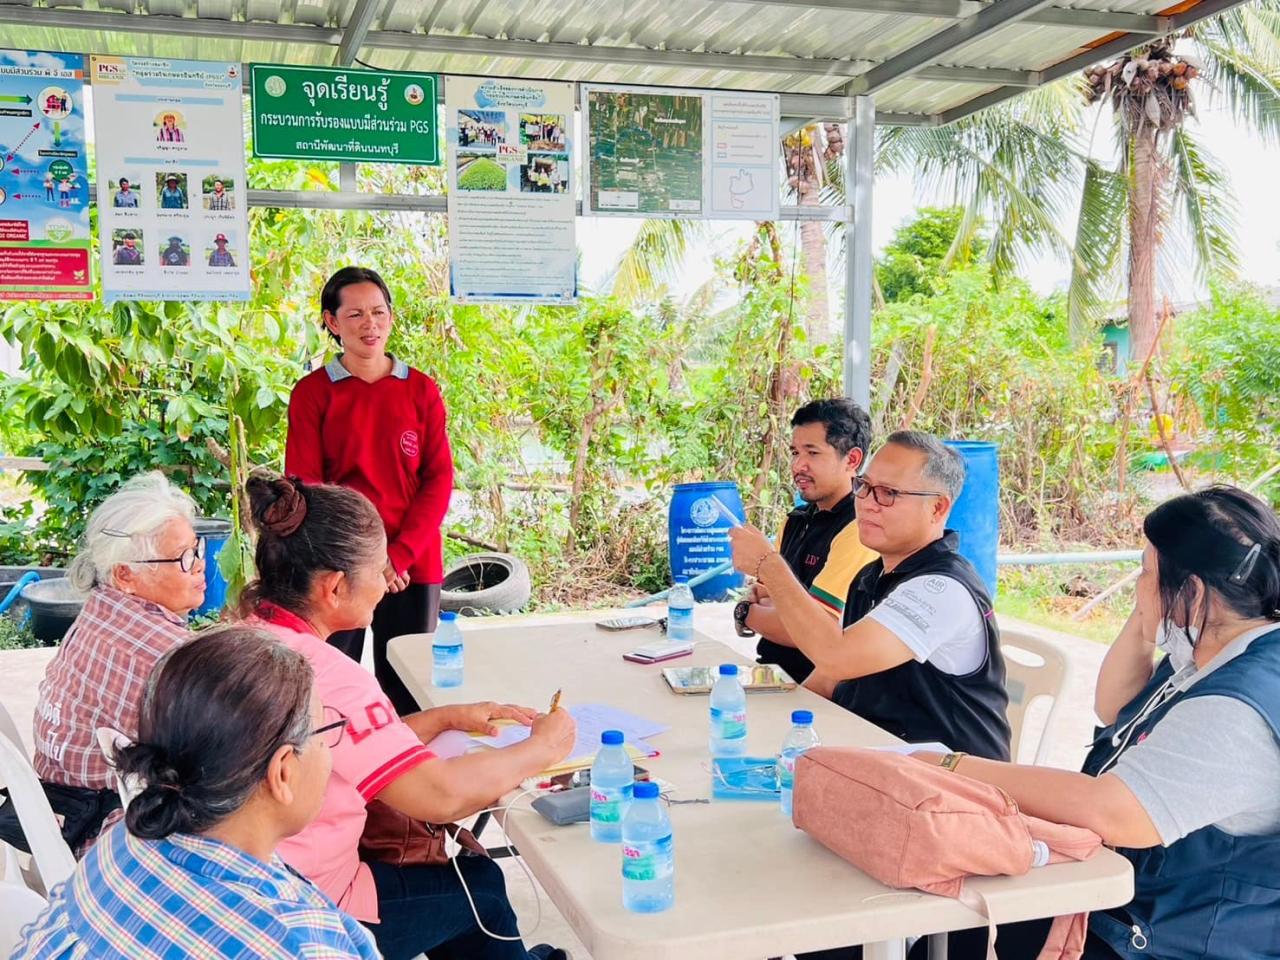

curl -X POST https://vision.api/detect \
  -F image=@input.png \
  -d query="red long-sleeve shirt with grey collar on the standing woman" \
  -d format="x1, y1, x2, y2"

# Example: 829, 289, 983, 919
284, 360, 453, 584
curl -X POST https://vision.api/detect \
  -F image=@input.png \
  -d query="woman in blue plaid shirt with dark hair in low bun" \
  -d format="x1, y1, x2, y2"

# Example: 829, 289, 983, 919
13, 627, 379, 960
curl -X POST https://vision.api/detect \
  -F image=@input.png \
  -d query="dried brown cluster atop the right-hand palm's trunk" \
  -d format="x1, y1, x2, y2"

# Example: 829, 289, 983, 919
1084, 44, 1199, 131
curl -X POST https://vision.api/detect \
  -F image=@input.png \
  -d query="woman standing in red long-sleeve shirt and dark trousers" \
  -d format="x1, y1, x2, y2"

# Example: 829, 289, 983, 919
284, 266, 453, 714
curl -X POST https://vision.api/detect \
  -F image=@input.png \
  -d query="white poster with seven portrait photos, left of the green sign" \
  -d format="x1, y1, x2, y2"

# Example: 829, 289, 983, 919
90, 56, 250, 302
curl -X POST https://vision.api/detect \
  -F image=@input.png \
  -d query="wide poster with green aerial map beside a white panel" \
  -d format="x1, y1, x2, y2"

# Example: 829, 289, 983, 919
582, 83, 781, 220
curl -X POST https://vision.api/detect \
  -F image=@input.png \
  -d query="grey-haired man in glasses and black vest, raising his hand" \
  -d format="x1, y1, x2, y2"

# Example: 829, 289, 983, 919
730, 430, 1010, 760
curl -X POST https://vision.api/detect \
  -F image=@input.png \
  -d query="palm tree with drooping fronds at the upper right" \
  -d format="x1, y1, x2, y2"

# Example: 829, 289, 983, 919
877, 0, 1280, 357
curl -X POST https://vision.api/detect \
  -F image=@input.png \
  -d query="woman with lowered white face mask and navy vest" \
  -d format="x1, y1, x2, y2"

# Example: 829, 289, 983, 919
919, 486, 1280, 960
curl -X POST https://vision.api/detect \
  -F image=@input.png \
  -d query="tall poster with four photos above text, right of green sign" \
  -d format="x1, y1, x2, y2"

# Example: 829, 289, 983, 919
444, 77, 577, 303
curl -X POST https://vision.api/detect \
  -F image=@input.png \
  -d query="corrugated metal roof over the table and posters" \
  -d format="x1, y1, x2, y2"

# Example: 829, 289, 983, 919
0, 0, 1238, 123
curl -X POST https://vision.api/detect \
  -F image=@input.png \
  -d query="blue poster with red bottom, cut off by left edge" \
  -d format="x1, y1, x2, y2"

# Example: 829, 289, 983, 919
0, 50, 93, 300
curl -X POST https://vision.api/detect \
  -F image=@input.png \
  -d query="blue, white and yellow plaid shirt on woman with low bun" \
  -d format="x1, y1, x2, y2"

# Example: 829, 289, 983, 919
12, 824, 379, 960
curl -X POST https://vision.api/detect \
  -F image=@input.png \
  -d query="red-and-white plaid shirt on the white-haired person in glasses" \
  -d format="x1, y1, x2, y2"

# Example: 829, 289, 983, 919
33, 586, 191, 790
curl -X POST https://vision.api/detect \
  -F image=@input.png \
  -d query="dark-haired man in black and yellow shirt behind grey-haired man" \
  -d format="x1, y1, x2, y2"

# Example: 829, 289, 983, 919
735, 397, 876, 682
